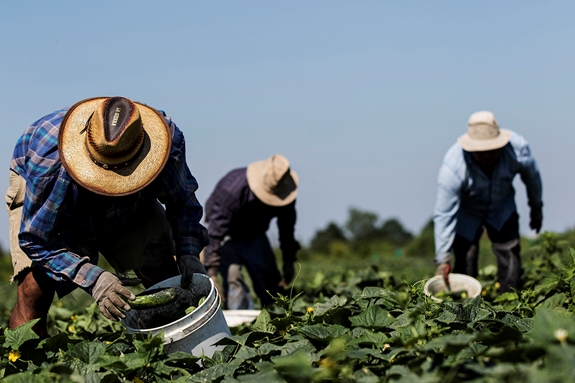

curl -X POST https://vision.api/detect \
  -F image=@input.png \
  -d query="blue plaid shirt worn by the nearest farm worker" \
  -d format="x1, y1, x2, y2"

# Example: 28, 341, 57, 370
10, 108, 208, 296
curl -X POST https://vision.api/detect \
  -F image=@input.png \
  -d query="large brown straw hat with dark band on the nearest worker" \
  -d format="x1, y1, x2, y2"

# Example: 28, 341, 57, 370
58, 97, 172, 196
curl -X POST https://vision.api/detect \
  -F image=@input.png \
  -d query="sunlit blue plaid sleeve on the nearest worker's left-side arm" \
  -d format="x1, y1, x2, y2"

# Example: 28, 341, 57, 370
11, 109, 103, 288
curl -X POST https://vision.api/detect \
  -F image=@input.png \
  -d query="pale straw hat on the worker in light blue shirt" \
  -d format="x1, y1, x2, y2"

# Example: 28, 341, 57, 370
457, 111, 511, 152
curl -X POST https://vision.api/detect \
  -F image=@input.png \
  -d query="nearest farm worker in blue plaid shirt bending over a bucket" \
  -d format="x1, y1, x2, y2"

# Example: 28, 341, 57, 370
6, 97, 208, 336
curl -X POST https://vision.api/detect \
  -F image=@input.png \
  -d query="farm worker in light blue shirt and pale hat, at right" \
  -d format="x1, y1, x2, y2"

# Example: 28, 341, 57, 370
433, 111, 543, 292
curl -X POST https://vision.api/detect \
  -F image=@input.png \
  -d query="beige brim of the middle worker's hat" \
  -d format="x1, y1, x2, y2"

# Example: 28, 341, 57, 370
246, 161, 299, 206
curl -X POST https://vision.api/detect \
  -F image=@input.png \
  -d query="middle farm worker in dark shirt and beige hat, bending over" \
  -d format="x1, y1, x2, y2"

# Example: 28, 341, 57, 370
204, 154, 300, 310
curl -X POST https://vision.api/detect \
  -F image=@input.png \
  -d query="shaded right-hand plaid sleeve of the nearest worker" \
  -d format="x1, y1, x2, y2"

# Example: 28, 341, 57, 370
158, 117, 208, 257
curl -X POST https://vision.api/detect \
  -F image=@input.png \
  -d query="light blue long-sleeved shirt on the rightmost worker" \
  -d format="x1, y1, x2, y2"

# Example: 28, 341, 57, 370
433, 132, 543, 264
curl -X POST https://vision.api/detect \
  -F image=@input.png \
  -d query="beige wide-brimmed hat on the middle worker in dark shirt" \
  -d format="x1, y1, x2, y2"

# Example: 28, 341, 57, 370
246, 154, 299, 206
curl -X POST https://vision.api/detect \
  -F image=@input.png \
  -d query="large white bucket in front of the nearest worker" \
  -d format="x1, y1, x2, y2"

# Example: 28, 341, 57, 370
123, 273, 231, 357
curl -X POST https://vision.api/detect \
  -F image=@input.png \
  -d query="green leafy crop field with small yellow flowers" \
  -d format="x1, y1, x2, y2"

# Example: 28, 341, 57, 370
0, 233, 575, 383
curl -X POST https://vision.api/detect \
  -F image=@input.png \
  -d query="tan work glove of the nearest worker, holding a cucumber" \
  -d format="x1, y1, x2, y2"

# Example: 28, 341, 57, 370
92, 271, 136, 321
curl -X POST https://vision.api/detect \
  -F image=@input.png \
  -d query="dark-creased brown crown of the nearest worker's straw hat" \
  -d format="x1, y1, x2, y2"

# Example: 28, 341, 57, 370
86, 97, 145, 168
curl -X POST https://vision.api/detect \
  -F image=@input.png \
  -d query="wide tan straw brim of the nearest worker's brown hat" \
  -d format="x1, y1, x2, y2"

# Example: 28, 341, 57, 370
58, 97, 172, 196
